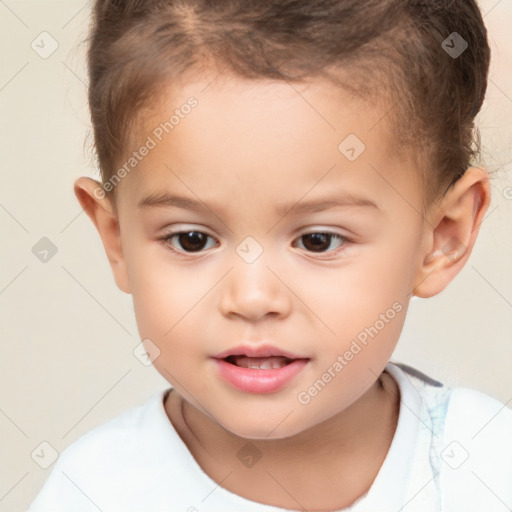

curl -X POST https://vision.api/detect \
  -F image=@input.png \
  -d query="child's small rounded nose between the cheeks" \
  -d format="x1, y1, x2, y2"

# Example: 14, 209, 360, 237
219, 255, 292, 322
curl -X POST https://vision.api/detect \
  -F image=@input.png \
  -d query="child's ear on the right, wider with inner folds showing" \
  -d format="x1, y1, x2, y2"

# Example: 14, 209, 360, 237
413, 167, 491, 298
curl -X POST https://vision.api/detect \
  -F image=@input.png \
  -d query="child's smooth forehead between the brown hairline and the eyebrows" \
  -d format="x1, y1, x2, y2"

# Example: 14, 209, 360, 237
117, 74, 420, 216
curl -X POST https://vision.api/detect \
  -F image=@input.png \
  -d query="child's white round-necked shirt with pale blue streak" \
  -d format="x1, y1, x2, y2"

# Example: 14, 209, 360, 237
29, 362, 512, 512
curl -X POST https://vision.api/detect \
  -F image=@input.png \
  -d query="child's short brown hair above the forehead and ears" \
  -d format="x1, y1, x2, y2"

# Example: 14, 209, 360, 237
88, 0, 490, 215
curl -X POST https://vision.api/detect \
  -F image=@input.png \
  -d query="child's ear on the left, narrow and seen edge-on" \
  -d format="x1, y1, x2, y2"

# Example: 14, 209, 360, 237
74, 177, 130, 293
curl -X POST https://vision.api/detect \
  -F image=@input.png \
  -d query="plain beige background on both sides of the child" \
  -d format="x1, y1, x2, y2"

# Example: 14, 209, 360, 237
0, 0, 512, 512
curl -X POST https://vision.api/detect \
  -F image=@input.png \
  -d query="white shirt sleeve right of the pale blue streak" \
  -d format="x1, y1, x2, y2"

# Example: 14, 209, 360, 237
440, 387, 512, 512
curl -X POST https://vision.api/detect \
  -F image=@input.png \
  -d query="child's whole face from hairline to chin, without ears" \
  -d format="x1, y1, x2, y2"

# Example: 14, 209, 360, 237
111, 72, 424, 439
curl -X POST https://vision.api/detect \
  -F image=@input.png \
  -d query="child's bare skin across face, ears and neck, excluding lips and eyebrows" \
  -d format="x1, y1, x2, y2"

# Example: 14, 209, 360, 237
75, 70, 490, 510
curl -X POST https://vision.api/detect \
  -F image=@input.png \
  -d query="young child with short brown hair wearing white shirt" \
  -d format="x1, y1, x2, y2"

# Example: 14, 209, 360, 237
30, 0, 512, 512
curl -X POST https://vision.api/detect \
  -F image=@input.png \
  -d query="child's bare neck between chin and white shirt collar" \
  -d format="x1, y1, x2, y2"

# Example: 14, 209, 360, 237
166, 373, 399, 510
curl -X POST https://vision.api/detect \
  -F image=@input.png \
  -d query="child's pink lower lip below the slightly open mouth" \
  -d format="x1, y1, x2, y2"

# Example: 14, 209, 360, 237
215, 359, 308, 393
